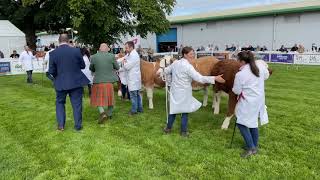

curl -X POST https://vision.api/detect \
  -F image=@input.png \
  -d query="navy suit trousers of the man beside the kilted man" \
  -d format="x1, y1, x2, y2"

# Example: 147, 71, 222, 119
56, 87, 83, 130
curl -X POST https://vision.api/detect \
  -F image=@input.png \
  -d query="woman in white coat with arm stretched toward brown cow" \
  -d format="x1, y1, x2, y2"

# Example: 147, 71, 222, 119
160, 47, 225, 136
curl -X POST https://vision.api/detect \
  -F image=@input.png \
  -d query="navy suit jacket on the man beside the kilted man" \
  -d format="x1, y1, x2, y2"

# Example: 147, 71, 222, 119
49, 44, 90, 91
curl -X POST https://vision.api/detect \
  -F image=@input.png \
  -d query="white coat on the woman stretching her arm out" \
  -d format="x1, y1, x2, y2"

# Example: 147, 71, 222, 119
164, 59, 215, 114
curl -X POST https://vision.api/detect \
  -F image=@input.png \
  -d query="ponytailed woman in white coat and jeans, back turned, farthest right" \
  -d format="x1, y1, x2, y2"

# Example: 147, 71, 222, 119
232, 51, 269, 157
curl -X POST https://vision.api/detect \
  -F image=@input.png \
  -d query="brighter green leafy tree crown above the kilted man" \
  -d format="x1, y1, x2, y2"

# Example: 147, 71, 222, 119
69, 0, 176, 47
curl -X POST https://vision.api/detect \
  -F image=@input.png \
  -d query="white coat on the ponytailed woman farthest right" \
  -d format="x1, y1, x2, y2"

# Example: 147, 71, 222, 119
232, 62, 269, 128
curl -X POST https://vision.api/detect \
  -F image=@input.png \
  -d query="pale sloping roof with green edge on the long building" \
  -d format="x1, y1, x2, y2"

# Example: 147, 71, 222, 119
168, 0, 320, 24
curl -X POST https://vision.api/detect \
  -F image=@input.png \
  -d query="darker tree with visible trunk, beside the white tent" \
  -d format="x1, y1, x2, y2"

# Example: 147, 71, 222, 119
0, 0, 71, 48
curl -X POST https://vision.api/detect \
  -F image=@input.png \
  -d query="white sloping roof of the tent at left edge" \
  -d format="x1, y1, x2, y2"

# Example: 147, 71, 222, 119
0, 20, 25, 37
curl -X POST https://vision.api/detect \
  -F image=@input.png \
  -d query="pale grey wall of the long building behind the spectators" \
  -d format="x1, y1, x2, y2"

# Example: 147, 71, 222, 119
141, 12, 320, 50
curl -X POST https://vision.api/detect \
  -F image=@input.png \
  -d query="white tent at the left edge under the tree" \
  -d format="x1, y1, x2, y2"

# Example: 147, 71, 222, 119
0, 20, 26, 58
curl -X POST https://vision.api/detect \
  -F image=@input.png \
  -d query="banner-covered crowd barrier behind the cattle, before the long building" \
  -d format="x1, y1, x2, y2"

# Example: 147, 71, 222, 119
154, 51, 320, 65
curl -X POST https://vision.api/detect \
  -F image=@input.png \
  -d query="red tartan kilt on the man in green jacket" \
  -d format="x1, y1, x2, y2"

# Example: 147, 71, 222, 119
90, 83, 114, 107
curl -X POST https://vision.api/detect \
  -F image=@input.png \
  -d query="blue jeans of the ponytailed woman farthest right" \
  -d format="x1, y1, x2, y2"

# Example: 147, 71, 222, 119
237, 124, 259, 149
